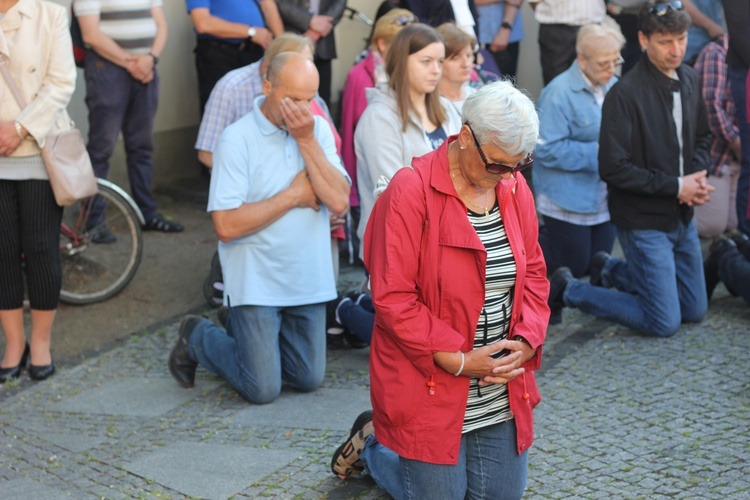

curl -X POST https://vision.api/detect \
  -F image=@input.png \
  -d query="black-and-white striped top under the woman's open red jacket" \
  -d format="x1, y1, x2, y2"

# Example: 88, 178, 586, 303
463, 204, 516, 433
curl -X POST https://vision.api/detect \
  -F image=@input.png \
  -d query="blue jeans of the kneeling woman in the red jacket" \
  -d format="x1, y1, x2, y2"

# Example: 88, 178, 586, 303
362, 420, 528, 500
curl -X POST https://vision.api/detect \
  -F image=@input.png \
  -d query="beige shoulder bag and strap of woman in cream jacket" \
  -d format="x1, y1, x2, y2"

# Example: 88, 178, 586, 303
0, 54, 97, 207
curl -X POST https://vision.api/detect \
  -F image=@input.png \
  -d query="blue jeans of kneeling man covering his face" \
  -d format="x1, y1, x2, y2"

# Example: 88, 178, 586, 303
189, 304, 326, 404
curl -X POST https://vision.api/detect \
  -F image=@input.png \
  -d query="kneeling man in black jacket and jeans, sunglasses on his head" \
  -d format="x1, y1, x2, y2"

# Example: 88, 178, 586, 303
550, 0, 713, 337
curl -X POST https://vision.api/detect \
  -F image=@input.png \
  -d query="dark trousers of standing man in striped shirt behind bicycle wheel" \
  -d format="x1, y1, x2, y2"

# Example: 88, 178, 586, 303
84, 50, 159, 221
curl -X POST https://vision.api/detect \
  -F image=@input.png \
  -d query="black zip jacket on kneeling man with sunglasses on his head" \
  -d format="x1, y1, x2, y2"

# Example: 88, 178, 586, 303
599, 55, 711, 231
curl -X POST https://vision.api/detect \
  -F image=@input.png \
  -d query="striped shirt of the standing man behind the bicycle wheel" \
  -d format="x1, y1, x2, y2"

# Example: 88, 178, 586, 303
73, 0, 162, 54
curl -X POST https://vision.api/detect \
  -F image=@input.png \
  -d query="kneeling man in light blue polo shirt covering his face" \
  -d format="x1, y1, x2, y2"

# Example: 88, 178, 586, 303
168, 52, 350, 404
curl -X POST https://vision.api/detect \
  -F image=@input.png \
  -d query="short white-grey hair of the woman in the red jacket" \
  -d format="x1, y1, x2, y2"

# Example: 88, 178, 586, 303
461, 80, 539, 156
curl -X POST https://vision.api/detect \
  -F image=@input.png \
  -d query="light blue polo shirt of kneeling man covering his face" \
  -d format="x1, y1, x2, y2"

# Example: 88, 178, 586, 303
208, 96, 348, 307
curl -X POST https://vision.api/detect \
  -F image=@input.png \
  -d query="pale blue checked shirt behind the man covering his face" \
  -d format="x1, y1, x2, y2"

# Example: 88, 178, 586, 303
195, 59, 263, 153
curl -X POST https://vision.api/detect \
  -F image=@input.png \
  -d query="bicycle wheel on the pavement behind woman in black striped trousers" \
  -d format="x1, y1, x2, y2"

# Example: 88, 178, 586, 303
60, 183, 143, 304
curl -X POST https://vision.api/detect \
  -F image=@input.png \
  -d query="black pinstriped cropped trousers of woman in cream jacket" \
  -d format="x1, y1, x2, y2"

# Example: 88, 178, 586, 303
0, 180, 63, 311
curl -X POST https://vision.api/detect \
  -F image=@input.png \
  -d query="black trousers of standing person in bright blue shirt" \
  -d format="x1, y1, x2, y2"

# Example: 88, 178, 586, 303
195, 38, 263, 116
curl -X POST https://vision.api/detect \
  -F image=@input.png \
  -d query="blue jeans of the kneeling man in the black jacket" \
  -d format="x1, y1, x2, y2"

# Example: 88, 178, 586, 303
563, 221, 708, 337
